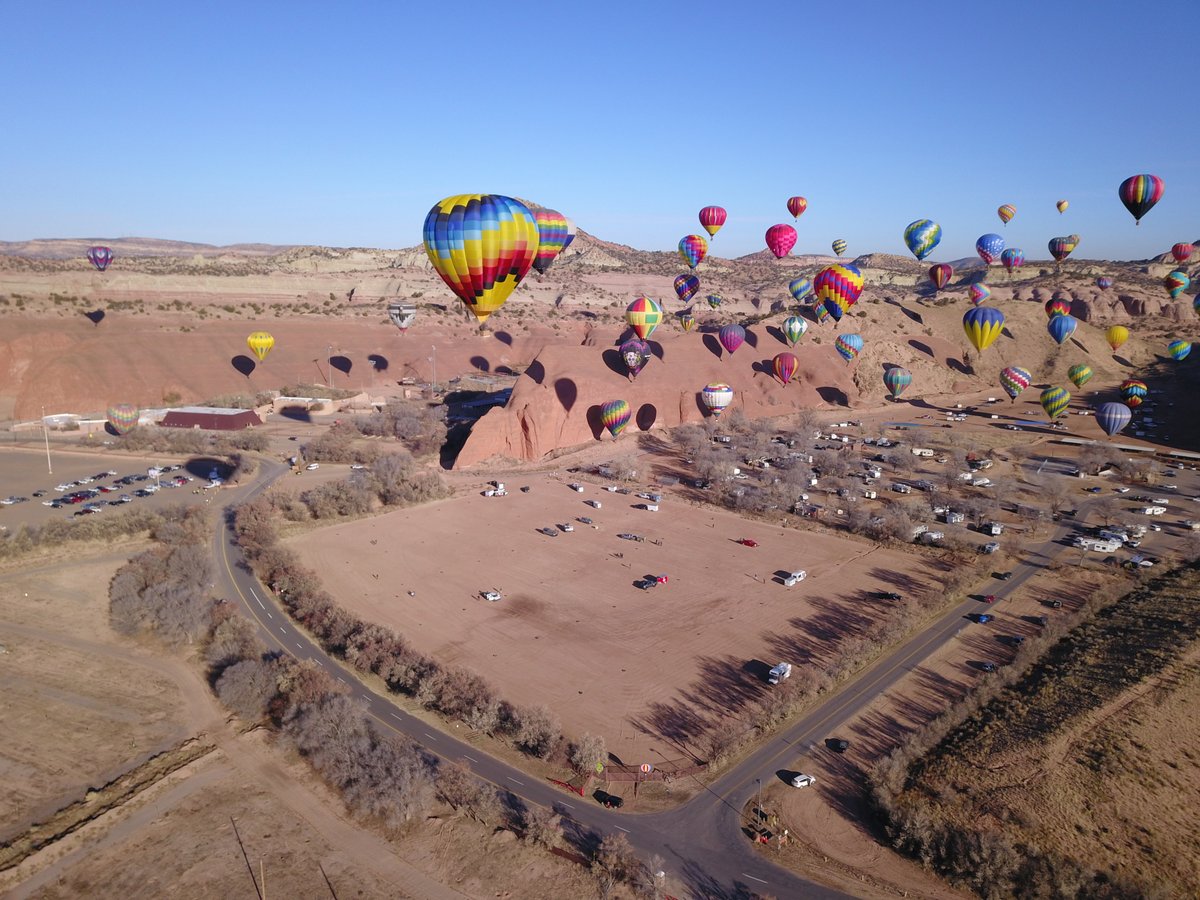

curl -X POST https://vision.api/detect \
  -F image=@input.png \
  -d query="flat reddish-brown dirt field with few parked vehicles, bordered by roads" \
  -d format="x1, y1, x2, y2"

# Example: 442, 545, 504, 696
285, 475, 936, 762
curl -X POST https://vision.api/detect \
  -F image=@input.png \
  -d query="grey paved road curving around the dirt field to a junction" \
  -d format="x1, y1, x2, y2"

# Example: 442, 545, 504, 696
212, 463, 1104, 898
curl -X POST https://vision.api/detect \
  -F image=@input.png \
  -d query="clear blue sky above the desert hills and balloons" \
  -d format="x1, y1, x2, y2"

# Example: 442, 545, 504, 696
0, 0, 1200, 262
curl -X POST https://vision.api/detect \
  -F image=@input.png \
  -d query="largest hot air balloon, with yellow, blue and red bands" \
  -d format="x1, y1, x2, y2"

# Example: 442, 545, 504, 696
424, 193, 539, 323
